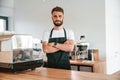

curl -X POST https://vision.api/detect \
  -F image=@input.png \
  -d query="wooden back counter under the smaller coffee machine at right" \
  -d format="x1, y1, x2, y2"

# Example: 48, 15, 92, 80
70, 60, 106, 74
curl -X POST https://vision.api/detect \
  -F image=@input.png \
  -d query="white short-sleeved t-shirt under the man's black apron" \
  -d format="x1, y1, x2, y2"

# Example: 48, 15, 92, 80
42, 29, 74, 42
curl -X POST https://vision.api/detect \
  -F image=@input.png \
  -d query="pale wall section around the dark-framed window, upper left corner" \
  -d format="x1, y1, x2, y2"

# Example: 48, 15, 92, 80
0, 0, 14, 31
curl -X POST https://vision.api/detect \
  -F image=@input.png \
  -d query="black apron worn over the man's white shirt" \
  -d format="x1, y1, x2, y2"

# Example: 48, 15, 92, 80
46, 28, 71, 70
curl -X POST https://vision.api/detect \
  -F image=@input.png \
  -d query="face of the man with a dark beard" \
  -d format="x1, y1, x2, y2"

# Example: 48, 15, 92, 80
52, 11, 64, 27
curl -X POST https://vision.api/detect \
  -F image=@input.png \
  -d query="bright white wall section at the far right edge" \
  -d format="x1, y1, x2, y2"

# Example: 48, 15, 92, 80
106, 0, 120, 74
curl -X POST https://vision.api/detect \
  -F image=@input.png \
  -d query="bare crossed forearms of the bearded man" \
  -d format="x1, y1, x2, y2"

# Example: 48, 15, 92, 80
42, 39, 74, 54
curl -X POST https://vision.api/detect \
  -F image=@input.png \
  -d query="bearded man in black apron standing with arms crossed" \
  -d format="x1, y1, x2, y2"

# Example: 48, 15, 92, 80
42, 7, 74, 70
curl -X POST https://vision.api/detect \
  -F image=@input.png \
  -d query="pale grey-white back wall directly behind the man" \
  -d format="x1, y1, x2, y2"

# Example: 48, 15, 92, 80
14, 0, 106, 59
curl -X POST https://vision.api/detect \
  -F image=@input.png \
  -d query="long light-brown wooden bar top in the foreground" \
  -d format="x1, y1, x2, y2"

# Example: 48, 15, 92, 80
0, 67, 120, 80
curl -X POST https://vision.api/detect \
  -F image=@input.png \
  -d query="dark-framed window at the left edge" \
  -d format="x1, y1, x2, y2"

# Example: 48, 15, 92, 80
0, 16, 8, 31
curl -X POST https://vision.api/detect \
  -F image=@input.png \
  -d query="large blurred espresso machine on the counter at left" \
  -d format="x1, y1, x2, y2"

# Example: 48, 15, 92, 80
0, 34, 43, 72
